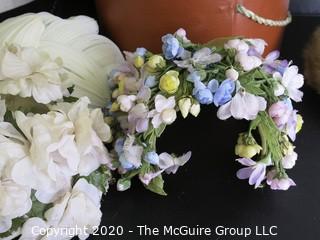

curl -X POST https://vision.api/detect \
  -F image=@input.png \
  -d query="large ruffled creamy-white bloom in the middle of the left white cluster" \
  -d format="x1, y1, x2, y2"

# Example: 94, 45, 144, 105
12, 112, 80, 203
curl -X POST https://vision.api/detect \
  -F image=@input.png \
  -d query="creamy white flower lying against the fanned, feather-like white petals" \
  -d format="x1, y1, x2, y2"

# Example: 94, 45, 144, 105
0, 45, 71, 104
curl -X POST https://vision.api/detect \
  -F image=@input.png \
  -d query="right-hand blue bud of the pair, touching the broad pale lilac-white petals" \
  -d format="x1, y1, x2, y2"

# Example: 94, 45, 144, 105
213, 79, 235, 107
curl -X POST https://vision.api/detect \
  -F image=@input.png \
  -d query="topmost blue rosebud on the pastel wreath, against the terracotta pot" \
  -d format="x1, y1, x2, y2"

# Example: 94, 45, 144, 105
162, 34, 184, 60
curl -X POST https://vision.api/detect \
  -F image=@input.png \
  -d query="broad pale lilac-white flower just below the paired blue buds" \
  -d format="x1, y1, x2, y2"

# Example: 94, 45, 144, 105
217, 91, 267, 120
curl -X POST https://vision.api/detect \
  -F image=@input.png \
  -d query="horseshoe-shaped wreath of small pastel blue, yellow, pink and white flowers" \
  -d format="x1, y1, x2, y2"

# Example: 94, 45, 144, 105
109, 29, 304, 195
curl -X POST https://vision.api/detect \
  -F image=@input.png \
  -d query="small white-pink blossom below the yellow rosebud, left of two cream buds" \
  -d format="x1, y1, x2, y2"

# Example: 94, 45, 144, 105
149, 94, 177, 128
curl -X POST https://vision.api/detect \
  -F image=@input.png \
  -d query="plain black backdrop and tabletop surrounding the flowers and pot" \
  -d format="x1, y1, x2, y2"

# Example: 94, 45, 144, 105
0, 0, 320, 240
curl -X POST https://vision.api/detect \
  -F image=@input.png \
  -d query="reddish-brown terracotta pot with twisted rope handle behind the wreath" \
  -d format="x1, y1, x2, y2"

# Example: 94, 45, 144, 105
96, 0, 289, 52
